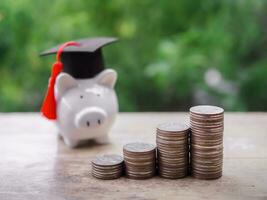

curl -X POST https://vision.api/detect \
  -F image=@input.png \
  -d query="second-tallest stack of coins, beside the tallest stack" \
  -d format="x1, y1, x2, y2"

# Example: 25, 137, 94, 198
156, 122, 190, 179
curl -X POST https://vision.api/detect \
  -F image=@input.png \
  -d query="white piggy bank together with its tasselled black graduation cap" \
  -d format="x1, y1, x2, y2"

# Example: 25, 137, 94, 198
41, 38, 118, 147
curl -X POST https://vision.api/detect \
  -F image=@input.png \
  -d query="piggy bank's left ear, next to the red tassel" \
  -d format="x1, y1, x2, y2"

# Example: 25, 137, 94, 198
55, 73, 78, 99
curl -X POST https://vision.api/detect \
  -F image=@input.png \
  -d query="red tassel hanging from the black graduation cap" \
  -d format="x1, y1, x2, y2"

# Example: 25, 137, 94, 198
41, 42, 79, 120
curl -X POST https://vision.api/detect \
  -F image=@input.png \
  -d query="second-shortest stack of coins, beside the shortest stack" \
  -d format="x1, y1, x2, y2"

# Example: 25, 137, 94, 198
123, 142, 156, 179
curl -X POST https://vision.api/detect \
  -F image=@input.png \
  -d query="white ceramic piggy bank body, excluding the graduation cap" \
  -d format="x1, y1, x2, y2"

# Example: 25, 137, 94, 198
55, 69, 118, 147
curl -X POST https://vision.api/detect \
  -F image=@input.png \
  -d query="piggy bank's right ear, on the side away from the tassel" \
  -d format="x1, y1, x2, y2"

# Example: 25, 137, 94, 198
96, 69, 117, 88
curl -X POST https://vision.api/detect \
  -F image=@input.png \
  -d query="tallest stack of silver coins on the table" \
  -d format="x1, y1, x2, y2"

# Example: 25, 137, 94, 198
190, 105, 224, 179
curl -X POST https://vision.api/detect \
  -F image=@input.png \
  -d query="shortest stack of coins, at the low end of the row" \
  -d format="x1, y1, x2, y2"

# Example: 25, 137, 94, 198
92, 154, 123, 180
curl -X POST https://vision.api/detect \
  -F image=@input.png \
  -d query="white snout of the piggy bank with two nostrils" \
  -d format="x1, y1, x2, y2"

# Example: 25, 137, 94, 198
75, 107, 107, 128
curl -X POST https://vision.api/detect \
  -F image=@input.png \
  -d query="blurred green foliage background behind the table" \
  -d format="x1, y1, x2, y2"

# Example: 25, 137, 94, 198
0, 0, 267, 112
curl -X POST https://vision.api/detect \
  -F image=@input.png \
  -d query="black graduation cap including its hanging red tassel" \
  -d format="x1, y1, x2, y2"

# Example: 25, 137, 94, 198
40, 38, 117, 120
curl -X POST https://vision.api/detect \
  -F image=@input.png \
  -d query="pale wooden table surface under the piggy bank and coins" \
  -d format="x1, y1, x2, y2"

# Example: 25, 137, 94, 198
0, 113, 267, 200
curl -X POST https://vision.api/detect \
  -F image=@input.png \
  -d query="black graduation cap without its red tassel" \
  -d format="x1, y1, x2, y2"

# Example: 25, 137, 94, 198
40, 37, 117, 79
